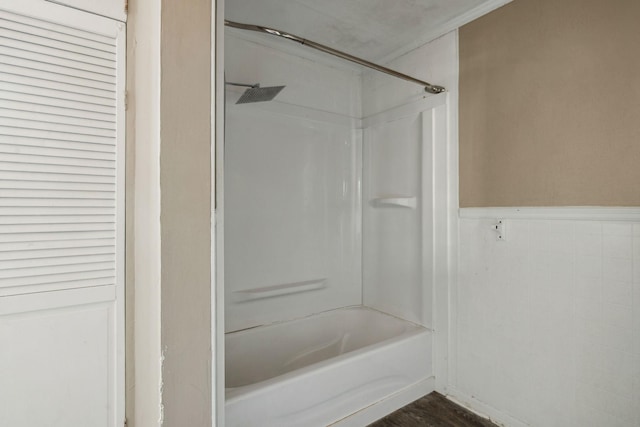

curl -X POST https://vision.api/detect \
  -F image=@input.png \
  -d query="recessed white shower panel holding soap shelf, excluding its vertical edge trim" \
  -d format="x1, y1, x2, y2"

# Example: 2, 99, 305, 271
363, 115, 424, 323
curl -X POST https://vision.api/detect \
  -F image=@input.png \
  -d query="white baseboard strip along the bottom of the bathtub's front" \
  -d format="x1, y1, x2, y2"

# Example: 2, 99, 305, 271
331, 377, 435, 427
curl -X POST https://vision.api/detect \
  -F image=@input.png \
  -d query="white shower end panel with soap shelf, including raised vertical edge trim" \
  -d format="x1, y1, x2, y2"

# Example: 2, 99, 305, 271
363, 95, 446, 327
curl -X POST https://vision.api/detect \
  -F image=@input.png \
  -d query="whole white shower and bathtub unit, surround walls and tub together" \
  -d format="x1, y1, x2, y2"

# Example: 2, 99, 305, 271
219, 10, 448, 427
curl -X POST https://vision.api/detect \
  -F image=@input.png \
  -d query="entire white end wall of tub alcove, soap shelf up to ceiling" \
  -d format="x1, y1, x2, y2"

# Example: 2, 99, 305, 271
362, 32, 457, 330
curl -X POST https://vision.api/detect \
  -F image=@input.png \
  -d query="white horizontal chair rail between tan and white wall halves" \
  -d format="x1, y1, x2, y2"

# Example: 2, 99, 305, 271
458, 206, 640, 222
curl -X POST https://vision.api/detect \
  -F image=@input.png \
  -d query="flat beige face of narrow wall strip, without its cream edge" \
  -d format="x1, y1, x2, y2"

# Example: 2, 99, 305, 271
160, 0, 211, 427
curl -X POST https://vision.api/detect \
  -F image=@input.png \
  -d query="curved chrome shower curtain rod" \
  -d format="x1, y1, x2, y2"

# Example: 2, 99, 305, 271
224, 20, 445, 93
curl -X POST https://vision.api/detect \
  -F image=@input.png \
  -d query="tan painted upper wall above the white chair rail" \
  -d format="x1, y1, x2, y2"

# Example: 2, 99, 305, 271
459, 0, 640, 207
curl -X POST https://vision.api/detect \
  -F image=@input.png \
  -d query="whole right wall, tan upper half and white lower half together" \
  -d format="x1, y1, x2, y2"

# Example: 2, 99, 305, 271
450, 0, 640, 427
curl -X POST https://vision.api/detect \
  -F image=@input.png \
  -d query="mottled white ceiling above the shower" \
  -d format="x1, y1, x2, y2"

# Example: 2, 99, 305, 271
225, 0, 509, 61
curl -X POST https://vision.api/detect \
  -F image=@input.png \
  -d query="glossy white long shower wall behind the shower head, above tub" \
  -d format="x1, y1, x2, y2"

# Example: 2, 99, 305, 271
224, 34, 362, 331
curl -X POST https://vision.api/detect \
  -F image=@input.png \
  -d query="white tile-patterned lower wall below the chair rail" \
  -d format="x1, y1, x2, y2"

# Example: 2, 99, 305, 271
452, 216, 640, 427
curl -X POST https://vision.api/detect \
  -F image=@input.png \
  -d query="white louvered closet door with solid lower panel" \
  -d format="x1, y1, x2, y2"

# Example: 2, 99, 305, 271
0, 0, 125, 427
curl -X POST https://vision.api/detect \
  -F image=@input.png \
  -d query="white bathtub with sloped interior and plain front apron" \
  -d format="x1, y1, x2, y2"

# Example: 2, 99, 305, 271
225, 307, 433, 427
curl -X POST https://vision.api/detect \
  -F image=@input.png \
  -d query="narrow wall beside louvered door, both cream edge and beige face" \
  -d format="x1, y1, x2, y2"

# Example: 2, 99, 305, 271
127, 0, 212, 427
